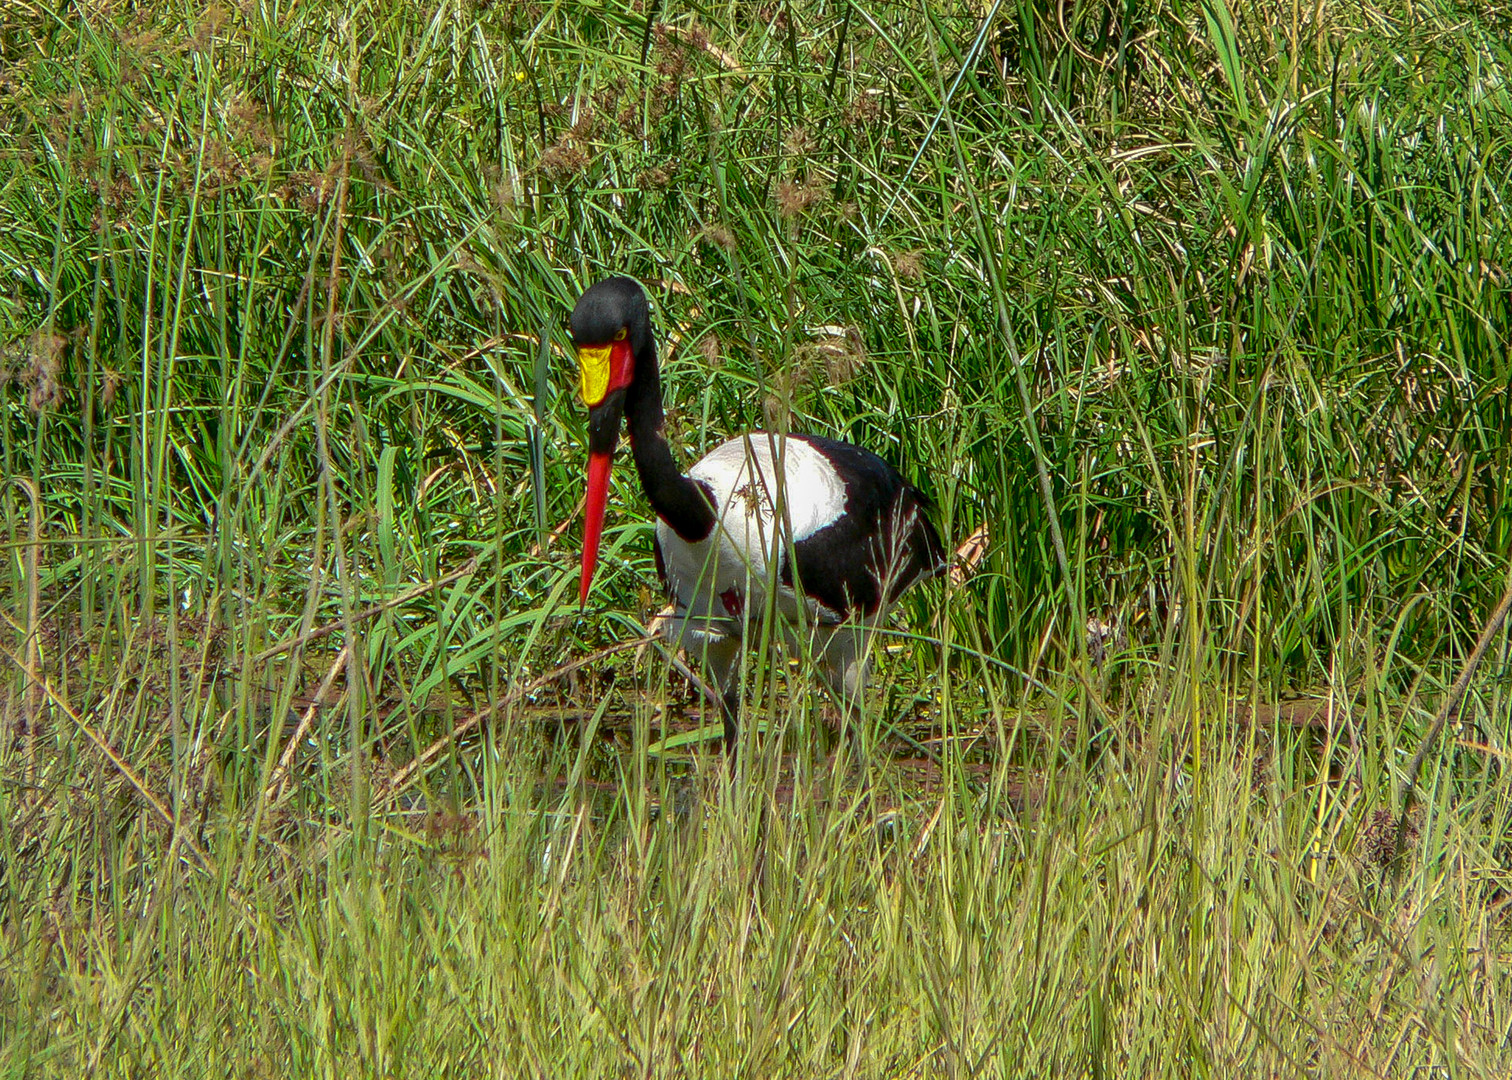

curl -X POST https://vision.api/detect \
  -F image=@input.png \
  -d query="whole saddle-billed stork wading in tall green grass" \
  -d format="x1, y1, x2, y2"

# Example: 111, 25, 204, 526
572, 277, 945, 750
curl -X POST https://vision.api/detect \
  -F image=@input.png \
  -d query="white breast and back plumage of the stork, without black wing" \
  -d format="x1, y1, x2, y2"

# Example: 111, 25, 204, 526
656, 431, 845, 629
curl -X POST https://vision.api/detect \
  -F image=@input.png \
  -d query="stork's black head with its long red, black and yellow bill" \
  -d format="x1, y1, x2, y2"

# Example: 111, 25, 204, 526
572, 277, 656, 604
